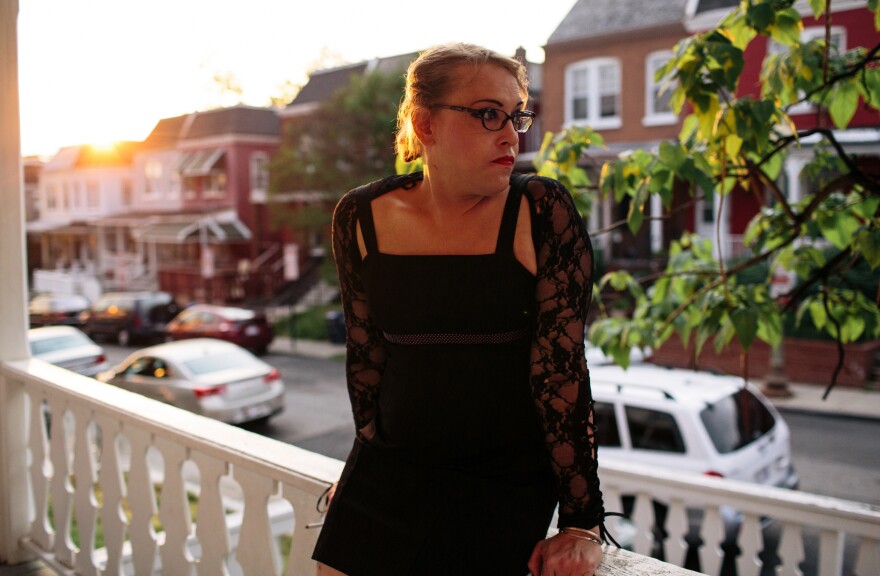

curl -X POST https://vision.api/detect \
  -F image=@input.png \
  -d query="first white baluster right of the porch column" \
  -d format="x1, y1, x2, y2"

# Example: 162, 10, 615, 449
28, 394, 53, 551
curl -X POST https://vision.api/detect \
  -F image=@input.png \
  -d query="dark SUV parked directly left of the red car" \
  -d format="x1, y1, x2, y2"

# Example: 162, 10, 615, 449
82, 292, 180, 346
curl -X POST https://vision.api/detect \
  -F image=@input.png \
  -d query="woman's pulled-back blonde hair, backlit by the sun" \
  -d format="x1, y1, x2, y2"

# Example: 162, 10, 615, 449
394, 43, 529, 162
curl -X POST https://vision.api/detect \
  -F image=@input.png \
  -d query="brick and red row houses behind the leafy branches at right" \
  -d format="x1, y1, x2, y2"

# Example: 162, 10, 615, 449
542, 0, 880, 271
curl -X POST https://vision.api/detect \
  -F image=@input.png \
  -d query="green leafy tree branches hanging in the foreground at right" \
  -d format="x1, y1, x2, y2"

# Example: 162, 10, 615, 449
536, 0, 880, 396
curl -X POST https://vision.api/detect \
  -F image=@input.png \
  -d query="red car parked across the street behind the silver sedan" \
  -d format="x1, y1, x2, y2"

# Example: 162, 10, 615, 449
166, 304, 275, 354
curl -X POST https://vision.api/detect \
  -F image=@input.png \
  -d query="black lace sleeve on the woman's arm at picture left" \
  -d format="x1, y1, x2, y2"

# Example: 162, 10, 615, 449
332, 192, 385, 439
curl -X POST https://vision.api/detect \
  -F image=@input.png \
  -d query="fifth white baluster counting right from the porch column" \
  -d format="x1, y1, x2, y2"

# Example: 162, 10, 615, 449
125, 426, 158, 574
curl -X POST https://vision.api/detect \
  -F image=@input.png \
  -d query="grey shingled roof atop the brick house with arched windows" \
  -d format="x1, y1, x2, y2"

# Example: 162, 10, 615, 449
547, 0, 687, 45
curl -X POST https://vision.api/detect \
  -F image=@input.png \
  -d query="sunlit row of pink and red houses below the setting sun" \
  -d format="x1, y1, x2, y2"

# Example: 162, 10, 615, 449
28, 106, 295, 302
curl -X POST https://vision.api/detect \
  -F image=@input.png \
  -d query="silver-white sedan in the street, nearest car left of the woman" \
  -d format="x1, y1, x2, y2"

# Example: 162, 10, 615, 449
98, 338, 284, 424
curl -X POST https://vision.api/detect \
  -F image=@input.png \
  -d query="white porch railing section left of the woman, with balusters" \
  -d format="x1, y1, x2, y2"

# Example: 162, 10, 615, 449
0, 360, 342, 576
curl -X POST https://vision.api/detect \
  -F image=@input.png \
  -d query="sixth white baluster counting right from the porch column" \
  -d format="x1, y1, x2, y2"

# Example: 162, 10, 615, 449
156, 438, 193, 576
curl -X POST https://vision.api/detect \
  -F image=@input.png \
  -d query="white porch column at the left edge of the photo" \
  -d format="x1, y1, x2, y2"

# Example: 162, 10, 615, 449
0, 0, 29, 564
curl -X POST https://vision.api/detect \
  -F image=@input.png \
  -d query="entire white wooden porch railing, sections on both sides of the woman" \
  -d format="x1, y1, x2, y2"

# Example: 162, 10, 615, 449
0, 360, 880, 576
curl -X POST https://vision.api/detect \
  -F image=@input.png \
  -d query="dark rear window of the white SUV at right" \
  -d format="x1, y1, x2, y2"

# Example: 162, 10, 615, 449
700, 389, 776, 454
